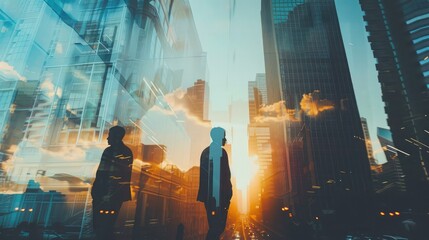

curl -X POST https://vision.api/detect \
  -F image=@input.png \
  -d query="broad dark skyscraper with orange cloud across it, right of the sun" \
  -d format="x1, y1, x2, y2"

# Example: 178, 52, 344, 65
261, 0, 372, 221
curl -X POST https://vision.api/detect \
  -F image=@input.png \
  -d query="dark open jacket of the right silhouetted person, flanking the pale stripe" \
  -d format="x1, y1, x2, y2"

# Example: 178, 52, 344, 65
197, 147, 232, 207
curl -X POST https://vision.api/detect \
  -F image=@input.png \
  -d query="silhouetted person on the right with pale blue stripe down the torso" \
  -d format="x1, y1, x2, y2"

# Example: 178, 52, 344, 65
197, 127, 232, 240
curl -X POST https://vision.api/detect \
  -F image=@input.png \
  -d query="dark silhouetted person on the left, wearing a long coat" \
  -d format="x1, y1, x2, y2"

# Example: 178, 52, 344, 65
91, 126, 133, 240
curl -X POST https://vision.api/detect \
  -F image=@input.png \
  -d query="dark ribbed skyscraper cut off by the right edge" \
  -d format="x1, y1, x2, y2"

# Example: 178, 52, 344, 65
360, 0, 429, 201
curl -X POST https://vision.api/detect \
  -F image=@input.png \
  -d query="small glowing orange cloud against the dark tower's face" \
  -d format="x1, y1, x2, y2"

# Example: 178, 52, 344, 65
299, 90, 334, 117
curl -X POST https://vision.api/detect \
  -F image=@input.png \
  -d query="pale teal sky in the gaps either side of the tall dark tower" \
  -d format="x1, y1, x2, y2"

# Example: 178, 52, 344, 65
189, 0, 387, 162
